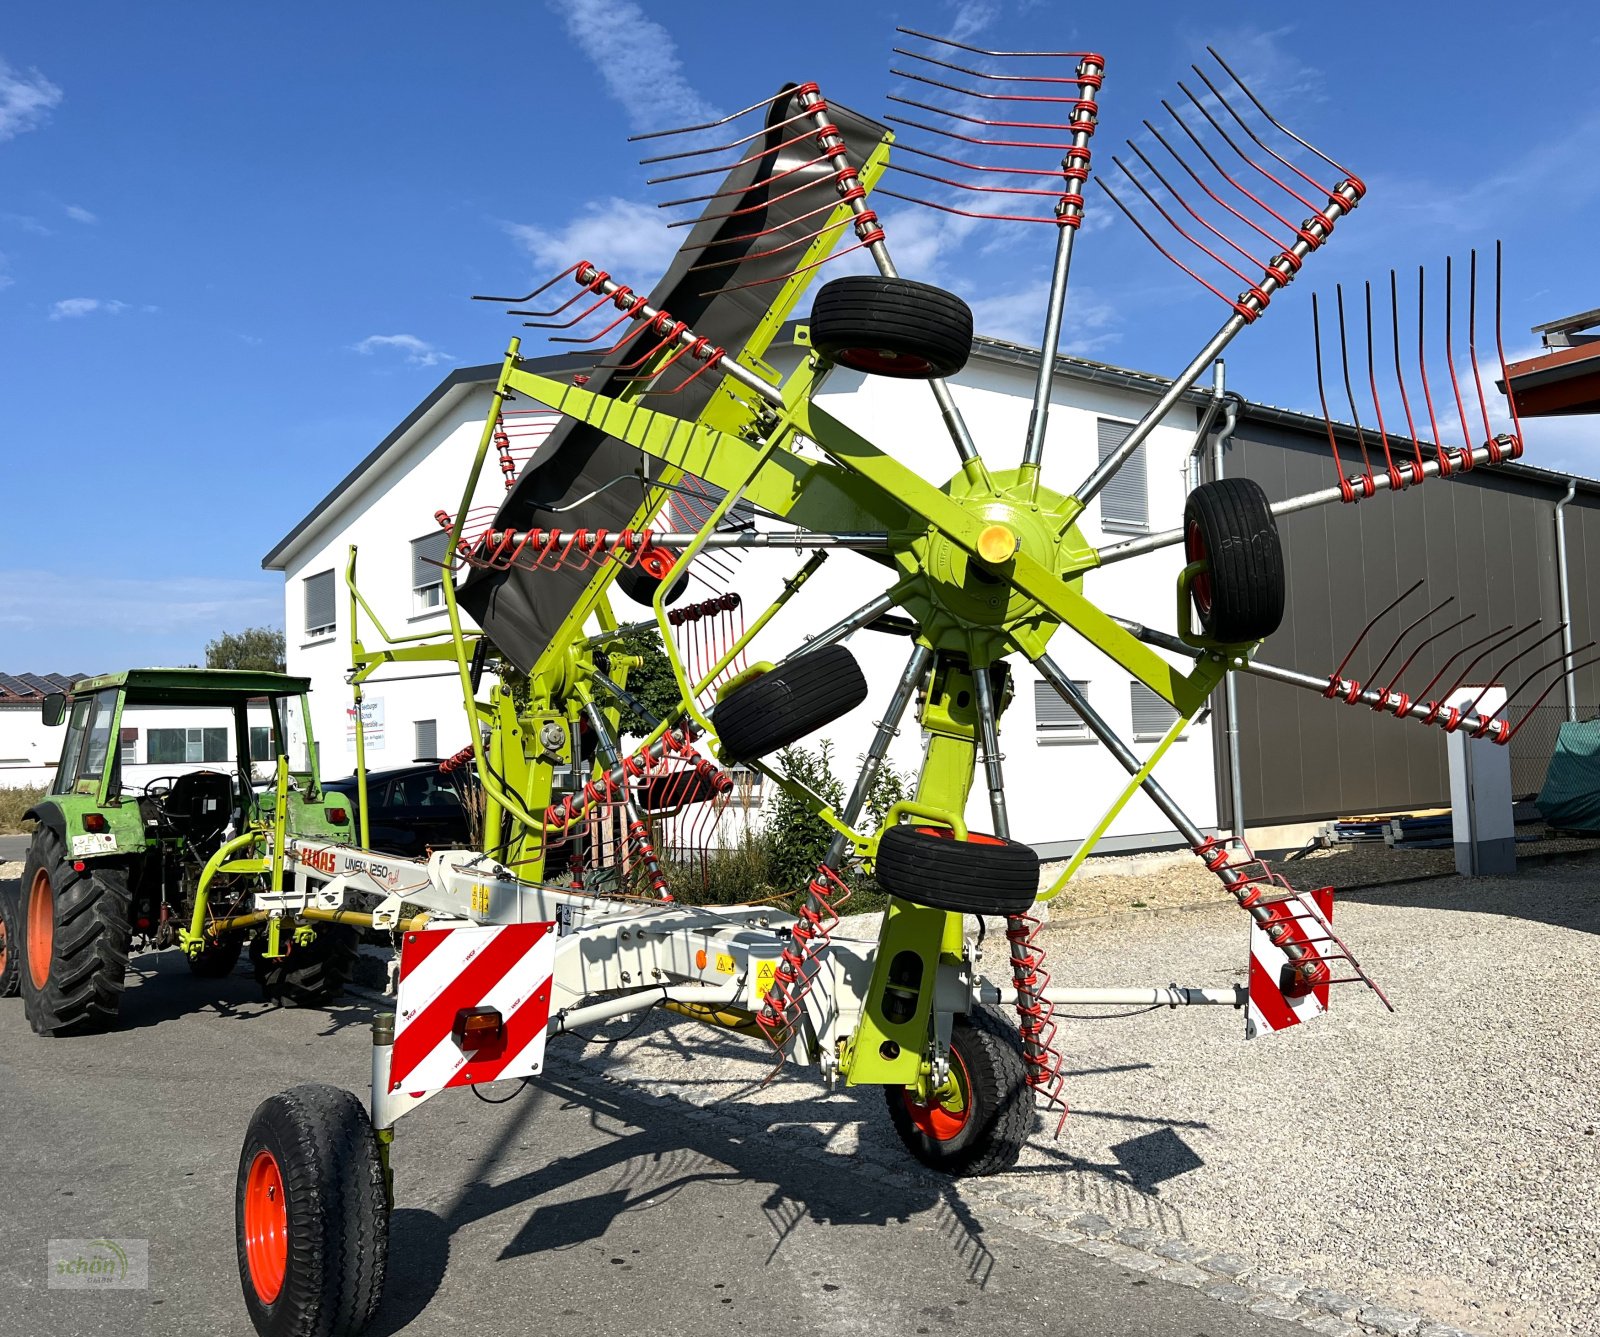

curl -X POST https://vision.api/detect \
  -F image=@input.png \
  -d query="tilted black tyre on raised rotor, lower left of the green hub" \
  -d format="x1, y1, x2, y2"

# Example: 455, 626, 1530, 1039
710, 645, 867, 761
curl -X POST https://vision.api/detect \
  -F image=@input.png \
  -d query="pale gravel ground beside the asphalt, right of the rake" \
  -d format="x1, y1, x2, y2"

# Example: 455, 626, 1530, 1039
544, 860, 1600, 1337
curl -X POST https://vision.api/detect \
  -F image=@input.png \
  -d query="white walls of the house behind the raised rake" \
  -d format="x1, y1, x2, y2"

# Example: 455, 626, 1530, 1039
262, 337, 1218, 857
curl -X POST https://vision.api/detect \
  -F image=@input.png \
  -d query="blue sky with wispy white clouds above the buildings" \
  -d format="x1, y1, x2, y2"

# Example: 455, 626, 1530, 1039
0, 0, 1600, 672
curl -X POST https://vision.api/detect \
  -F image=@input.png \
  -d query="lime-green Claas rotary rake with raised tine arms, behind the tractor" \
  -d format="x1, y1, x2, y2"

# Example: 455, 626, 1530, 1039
225, 34, 1548, 1332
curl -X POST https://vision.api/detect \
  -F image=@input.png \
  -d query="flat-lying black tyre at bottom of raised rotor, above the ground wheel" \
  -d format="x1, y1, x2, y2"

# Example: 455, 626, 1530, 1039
874, 825, 1038, 915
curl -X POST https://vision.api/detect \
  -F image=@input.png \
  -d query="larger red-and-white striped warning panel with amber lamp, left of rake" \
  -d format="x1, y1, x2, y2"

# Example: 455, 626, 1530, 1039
389, 924, 555, 1096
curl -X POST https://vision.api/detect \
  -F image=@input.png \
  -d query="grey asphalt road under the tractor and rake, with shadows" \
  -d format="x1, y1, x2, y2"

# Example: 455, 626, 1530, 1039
0, 952, 1304, 1337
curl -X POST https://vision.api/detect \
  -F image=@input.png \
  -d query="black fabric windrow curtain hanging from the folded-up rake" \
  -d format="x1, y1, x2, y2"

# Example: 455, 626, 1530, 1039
459, 85, 885, 672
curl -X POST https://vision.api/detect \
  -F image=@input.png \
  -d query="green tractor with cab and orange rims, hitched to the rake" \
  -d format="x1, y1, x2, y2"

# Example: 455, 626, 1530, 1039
8, 669, 357, 1035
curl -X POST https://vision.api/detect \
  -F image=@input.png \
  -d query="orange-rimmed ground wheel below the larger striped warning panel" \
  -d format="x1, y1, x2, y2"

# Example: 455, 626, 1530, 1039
234, 1084, 389, 1337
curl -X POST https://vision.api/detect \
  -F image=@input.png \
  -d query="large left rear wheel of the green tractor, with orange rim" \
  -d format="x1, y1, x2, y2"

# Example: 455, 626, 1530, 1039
18, 827, 133, 1035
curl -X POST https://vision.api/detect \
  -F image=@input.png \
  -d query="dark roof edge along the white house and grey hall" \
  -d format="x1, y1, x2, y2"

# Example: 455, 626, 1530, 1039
261, 321, 1600, 571
